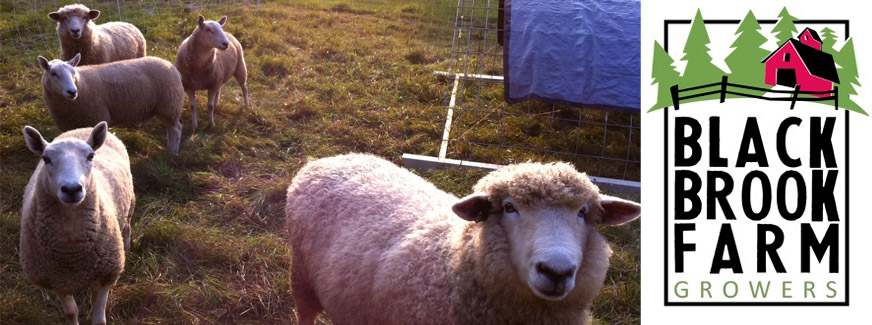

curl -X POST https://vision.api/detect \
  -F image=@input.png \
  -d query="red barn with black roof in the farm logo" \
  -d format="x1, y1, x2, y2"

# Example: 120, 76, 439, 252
762, 28, 839, 97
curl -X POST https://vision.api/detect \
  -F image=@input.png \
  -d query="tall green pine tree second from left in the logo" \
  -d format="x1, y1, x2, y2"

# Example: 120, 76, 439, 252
680, 10, 726, 102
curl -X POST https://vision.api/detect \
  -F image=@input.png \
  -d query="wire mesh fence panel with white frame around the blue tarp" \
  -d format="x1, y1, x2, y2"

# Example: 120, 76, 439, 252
440, 0, 641, 181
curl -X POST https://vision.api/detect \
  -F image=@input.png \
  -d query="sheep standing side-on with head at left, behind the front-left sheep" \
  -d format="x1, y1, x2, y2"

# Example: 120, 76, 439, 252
38, 54, 185, 154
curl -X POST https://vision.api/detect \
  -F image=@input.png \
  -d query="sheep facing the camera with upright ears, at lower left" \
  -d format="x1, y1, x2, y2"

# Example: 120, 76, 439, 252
19, 122, 136, 324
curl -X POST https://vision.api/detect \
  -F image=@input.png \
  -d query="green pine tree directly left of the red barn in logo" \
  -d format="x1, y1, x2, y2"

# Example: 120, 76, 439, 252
724, 10, 772, 97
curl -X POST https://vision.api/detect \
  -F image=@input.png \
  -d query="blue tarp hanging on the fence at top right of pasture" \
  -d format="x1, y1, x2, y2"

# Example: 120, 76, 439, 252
503, 0, 641, 113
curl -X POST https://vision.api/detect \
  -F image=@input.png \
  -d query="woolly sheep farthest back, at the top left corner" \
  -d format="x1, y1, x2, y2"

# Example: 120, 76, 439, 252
48, 4, 145, 65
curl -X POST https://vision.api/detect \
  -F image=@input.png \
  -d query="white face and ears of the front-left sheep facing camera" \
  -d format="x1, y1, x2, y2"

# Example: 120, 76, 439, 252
24, 122, 108, 206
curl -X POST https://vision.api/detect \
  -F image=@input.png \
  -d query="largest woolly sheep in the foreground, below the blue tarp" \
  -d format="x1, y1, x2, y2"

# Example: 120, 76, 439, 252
285, 154, 641, 325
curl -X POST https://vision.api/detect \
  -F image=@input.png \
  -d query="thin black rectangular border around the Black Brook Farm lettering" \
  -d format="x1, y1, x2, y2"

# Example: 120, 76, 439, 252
663, 19, 851, 307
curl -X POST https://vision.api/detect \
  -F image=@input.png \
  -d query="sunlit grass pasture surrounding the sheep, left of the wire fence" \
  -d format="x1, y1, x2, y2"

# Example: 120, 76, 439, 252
0, 1, 640, 324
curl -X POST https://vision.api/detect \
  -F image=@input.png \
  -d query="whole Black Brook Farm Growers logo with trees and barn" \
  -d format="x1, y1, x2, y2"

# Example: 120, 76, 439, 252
651, 8, 865, 305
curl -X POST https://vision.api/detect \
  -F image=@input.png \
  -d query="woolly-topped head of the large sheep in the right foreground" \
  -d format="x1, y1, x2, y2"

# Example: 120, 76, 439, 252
452, 163, 641, 300
